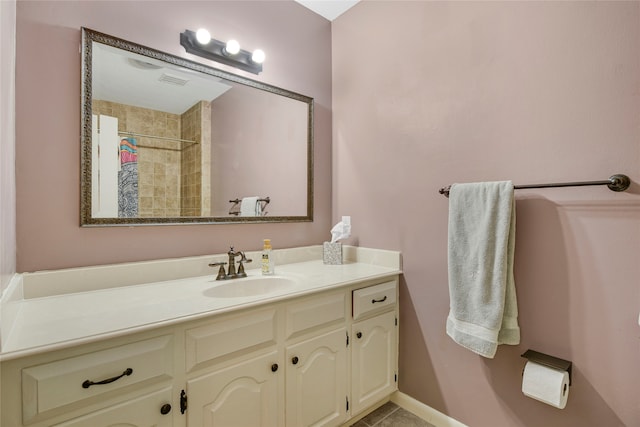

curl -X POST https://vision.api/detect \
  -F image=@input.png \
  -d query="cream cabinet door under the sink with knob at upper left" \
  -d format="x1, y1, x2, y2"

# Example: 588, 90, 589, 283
286, 328, 348, 427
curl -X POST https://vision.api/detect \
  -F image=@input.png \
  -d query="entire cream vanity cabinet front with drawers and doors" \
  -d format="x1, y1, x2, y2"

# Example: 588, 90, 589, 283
0, 276, 398, 427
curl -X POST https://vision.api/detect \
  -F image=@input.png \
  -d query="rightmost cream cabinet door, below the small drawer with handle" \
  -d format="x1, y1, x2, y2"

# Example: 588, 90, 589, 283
351, 312, 398, 414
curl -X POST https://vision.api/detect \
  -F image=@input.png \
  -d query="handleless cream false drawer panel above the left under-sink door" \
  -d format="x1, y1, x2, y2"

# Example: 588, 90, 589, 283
185, 308, 277, 372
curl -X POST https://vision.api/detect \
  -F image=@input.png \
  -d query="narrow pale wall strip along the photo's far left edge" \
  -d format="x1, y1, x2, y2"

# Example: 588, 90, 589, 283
0, 1, 16, 295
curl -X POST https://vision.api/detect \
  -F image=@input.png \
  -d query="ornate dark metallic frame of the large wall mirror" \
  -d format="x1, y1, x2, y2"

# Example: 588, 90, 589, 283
80, 27, 314, 227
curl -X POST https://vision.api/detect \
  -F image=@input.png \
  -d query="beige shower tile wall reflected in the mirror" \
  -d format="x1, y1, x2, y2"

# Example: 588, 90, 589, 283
93, 100, 211, 217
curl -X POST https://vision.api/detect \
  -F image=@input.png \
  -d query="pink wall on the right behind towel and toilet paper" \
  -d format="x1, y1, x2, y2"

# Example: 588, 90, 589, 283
332, 1, 640, 427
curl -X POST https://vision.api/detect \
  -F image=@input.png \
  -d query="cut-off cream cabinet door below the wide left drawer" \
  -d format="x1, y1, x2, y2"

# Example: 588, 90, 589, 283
54, 388, 176, 427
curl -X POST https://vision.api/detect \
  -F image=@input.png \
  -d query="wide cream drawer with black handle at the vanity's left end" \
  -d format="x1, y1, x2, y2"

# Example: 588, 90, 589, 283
22, 335, 173, 424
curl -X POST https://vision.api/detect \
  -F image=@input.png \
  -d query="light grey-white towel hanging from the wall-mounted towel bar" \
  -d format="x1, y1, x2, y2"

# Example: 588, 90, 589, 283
447, 181, 520, 358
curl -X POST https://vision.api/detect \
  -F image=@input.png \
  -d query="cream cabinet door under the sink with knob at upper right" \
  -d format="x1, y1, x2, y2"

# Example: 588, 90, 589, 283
187, 351, 284, 427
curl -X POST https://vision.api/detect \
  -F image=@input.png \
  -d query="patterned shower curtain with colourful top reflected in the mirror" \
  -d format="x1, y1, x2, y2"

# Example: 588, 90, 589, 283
118, 138, 138, 218
